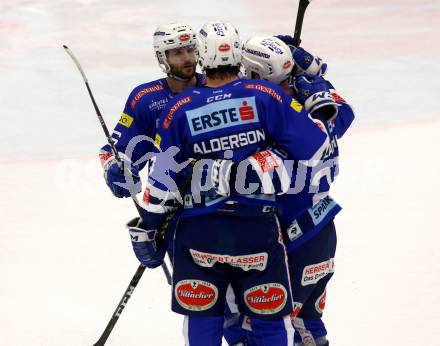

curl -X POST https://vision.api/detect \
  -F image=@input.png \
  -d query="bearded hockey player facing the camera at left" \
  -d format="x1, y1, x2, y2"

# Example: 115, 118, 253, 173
100, 23, 204, 198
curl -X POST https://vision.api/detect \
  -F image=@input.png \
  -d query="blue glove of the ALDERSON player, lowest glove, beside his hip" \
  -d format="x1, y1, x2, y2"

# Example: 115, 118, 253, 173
126, 217, 168, 268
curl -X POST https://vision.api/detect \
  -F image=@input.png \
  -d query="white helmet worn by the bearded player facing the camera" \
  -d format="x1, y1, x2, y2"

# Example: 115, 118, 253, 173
153, 23, 197, 73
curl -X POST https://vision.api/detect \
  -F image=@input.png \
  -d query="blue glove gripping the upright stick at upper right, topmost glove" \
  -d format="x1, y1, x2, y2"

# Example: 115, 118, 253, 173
276, 35, 327, 76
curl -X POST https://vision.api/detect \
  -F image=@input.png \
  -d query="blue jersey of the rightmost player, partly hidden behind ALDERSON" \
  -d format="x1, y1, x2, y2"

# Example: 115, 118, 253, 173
220, 82, 354, 250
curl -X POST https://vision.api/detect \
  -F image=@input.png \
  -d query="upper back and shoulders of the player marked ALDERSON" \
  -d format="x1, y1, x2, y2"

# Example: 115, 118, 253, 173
159, 80, 325, 162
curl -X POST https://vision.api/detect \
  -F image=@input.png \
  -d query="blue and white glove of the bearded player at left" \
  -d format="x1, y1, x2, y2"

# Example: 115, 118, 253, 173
100, 154, 142, 198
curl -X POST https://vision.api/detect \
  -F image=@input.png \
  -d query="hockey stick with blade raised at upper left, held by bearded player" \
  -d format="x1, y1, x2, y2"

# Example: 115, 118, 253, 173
63, 45, 171, 285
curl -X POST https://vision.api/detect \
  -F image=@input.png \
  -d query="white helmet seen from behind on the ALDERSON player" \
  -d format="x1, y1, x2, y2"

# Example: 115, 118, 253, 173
197, 22, 241, 70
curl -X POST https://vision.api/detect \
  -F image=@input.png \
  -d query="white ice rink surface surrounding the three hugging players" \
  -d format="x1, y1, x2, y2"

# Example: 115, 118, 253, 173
0, 0, 440, 346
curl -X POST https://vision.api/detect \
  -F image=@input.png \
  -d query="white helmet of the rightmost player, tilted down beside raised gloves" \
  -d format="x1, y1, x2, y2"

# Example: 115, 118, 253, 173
242, 36, 294, 84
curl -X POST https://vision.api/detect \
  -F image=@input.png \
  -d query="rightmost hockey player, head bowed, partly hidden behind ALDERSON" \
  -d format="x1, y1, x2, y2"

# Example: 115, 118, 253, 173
208, 36, 354, 346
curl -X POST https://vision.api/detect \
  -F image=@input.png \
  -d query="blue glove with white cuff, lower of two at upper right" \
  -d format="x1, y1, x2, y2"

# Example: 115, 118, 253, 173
293, 73, 338, 121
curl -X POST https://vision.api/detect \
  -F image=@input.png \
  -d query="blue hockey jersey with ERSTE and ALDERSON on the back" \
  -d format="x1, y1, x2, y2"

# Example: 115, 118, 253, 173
143, 80, 328, 227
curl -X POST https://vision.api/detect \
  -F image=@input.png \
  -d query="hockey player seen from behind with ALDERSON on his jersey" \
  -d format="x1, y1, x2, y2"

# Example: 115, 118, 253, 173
124, 23, 328, 346
